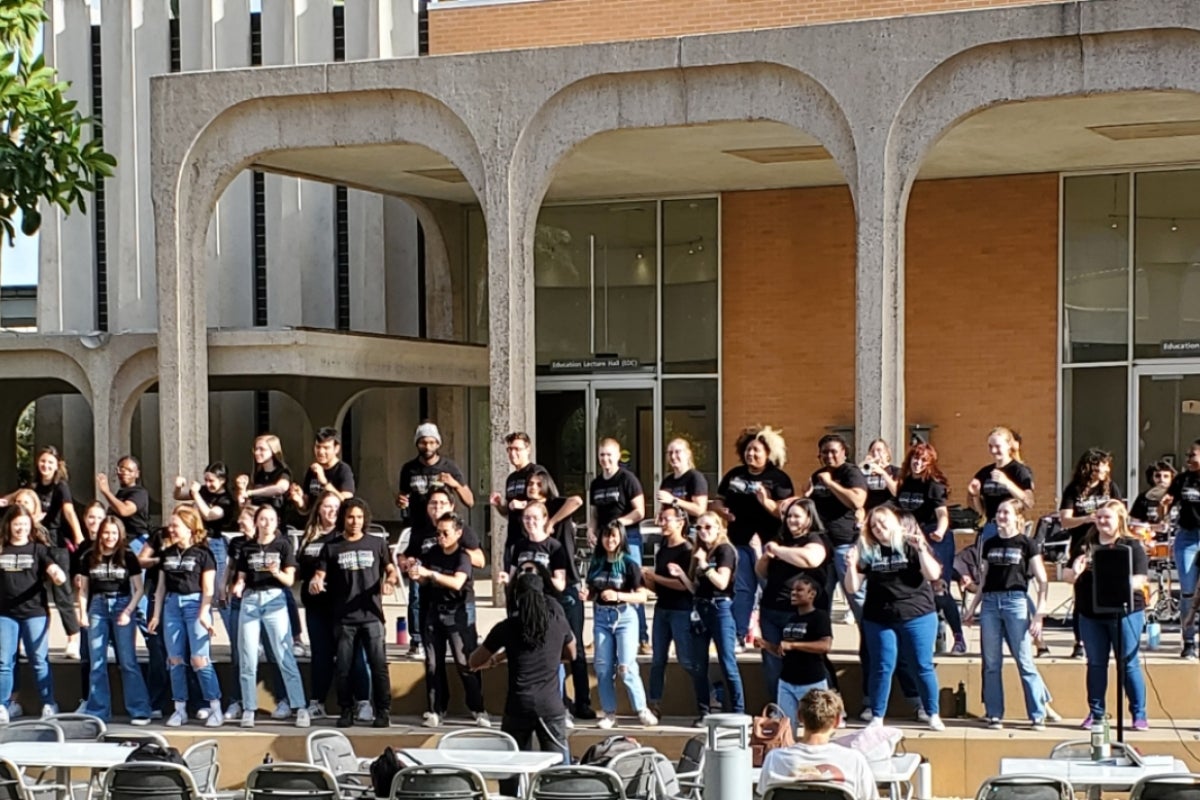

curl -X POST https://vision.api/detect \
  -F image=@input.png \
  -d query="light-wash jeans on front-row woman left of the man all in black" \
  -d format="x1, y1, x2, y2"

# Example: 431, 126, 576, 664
238, 589, 305, 711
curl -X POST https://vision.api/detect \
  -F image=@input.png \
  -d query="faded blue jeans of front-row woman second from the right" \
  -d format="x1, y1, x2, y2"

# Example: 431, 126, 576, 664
979, 589, 1046, 722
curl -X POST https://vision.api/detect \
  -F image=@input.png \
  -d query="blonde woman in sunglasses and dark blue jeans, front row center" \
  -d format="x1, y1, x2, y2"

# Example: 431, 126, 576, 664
667, 511, 745, 724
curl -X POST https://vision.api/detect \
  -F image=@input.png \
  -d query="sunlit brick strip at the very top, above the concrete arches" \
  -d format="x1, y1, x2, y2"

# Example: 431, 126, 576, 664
430, 0, 1058, 54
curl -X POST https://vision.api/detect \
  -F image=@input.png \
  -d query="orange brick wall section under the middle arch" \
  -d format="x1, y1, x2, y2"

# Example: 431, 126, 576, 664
721, 186, 854, 488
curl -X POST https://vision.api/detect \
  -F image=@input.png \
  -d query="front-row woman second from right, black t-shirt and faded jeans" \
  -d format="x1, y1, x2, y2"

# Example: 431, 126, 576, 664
967, 500, 1049, 730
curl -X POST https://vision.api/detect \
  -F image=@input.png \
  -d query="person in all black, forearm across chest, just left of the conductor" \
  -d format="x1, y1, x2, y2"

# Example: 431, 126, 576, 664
408, 513, 492, 728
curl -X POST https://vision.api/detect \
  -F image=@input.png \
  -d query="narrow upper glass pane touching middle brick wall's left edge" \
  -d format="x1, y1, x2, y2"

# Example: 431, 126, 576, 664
662, 199, 718, 374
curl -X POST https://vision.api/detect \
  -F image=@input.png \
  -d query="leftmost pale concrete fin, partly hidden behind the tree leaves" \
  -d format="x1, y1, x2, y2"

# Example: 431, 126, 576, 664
37, 0, 96, 332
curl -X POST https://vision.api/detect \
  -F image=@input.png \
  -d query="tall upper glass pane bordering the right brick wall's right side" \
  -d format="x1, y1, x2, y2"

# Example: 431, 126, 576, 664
1062, 175, 1129, 363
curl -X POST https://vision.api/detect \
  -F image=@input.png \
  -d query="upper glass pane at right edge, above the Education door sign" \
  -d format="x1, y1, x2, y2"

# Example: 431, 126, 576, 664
1134, 169, 1200, 359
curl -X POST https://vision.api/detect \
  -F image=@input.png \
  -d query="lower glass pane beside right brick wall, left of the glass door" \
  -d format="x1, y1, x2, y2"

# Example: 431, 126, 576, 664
1061, 367, 1136, 494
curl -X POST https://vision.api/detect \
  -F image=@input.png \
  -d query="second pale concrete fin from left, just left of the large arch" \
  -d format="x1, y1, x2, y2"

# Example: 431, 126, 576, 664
101, 0, 170, 331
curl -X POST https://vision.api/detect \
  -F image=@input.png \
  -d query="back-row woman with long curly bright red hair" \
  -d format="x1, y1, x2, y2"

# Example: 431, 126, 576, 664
895, 441, 967, 654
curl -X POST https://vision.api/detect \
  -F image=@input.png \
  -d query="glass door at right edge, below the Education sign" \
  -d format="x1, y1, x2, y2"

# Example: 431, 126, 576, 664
1137, 363, 1200, 484
